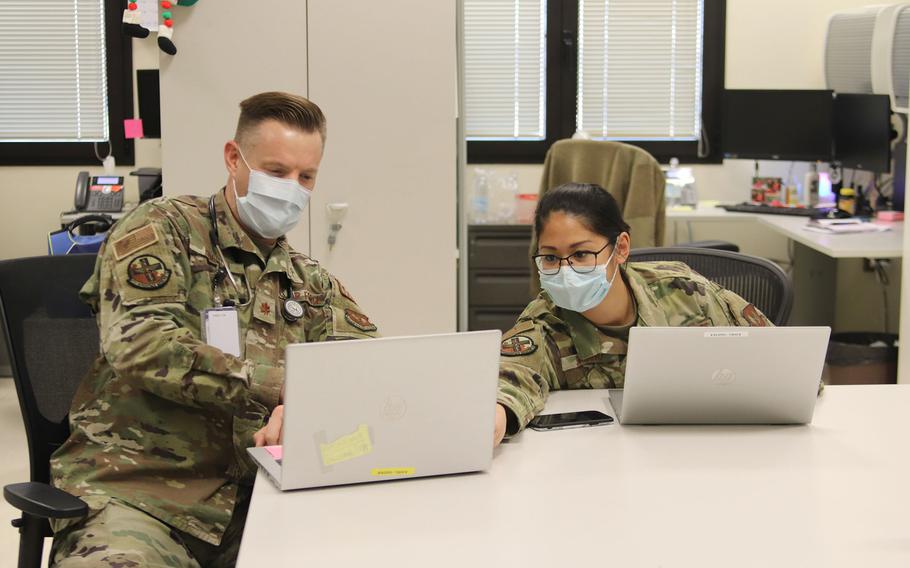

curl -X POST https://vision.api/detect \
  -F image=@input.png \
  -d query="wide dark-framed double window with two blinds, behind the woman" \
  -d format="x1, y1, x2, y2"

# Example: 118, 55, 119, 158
464, 0, 725, 163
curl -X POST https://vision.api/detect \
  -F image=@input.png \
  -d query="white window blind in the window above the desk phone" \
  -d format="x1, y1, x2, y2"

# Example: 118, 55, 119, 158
0, 0, 109, 142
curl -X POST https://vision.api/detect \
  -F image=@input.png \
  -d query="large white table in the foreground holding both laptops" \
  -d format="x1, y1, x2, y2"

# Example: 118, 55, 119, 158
238, 386, 910, 568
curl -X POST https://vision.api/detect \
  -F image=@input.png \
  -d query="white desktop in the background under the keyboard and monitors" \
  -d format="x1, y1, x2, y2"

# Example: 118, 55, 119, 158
667, 204, 904, 258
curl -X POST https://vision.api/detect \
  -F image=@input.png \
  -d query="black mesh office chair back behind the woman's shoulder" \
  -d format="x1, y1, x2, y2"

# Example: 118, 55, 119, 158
629, 247, 793, 325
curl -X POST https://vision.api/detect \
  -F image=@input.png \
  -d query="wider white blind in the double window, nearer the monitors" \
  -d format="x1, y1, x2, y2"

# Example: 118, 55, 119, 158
576, 0, 704, 140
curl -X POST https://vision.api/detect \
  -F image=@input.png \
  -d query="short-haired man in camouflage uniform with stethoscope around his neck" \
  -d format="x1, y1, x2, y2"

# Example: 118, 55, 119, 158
51, 93, 377, 567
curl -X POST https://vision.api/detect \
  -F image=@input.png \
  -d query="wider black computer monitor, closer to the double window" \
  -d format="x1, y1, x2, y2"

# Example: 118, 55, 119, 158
721, 89, 834, 162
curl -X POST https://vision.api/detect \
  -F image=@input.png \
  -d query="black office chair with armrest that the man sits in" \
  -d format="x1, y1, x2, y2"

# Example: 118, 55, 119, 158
0, 254, 98, 568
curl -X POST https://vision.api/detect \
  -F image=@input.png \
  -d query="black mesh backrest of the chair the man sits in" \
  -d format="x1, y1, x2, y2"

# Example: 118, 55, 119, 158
0, 254, 99, 483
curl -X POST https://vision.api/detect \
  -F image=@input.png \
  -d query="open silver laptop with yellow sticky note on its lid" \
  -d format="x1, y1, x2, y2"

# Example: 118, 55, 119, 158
247, 331, 502, 490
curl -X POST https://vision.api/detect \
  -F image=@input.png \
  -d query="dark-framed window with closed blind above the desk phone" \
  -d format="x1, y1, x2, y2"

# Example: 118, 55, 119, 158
0, 0, 134, 165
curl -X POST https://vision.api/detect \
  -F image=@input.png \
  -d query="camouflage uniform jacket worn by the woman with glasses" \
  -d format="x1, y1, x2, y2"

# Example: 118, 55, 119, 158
497, 262, 772, 436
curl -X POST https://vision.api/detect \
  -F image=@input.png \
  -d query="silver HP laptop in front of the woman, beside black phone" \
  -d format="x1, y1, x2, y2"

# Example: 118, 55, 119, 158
610, 327, 831, 424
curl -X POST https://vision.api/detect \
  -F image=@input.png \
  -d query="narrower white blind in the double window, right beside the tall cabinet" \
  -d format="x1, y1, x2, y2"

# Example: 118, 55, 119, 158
464, 0, 547, 140
